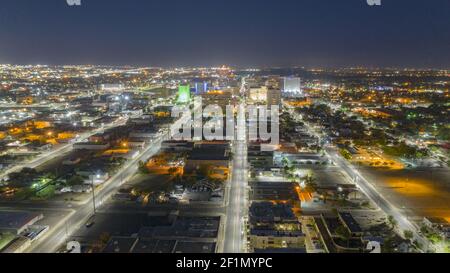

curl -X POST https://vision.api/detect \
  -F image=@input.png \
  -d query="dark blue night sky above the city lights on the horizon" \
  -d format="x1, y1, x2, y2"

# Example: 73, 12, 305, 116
0, 0, 450, 69
